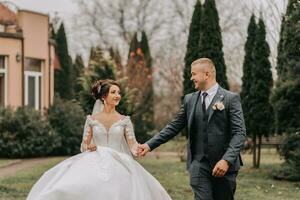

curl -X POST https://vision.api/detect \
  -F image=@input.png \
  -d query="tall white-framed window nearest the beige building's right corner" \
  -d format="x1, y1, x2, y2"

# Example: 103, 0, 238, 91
25, 58, 43, 110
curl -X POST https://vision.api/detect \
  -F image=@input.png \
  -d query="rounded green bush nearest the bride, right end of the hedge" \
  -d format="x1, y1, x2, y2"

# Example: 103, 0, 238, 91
48, 97, 85, 155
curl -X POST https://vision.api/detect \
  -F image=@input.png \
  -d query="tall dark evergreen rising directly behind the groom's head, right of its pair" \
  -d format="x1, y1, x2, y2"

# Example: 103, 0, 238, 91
198, 0, 229, 89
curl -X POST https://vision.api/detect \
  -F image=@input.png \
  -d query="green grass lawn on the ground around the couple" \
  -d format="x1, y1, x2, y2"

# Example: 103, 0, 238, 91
0, 150, 300, 200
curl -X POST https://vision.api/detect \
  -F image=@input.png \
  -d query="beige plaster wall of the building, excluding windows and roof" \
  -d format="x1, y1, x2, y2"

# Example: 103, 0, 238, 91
0, 10, 55, 110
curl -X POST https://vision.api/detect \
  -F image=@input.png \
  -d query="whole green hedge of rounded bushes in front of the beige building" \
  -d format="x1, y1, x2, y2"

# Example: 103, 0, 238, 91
0, 98, 85, 158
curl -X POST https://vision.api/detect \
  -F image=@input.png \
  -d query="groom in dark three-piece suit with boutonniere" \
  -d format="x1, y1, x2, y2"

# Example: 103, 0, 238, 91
139, 58, 246, 200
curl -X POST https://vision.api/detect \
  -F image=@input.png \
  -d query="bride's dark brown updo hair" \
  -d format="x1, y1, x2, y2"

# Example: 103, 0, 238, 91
92, 79, 120, 101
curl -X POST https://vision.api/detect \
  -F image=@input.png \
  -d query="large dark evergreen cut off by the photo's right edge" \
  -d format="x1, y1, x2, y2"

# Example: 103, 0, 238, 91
273, 0, 300, 133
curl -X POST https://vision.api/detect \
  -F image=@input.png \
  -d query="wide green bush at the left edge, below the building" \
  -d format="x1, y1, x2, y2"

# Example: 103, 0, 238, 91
0, 107, 60, 158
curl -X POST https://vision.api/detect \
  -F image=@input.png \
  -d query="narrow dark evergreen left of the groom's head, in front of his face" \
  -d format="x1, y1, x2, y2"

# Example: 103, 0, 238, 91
183, 0, 202, 95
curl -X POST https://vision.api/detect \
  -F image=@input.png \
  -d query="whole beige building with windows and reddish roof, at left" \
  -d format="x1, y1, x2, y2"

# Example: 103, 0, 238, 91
0, 3, 55, 110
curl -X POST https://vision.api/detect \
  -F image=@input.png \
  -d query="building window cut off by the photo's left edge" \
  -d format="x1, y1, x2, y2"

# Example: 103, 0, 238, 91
0, 55, 7, 106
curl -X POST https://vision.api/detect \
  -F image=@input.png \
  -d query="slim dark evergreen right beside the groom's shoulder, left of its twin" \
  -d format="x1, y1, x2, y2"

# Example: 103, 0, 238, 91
241, 14, 257, 136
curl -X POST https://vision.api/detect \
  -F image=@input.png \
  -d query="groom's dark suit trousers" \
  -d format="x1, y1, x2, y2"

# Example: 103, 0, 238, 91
190, 159, 238, 200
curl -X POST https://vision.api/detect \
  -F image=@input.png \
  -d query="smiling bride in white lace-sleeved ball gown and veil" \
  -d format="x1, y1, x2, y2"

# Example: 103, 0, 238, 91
27, 80, 171, 200
